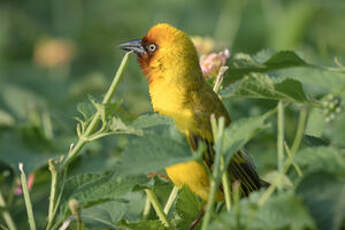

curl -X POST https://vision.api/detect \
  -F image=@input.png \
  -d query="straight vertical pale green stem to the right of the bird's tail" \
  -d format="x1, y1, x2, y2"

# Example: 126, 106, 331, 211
277, 101, 284, 172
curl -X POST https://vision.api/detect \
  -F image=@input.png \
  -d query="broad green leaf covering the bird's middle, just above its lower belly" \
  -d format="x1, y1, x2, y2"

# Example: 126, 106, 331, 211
122, 126, 196, 175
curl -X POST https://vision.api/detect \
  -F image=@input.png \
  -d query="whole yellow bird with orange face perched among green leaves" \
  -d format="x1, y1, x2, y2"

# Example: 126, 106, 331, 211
120, 24, 263, 201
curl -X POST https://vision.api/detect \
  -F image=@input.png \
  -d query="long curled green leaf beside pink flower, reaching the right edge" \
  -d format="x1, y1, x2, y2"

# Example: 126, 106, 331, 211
223, 50, 345, 99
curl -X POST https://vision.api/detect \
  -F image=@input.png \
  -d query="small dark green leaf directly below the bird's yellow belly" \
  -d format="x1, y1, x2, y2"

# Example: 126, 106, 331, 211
175, 186, 202, 229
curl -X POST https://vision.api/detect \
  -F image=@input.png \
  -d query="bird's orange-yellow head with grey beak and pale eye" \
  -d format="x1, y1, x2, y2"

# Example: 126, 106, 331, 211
120, 24, 201, 82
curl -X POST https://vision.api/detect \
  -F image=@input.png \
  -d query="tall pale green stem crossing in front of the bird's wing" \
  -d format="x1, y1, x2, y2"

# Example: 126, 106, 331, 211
201, 117, 225, 230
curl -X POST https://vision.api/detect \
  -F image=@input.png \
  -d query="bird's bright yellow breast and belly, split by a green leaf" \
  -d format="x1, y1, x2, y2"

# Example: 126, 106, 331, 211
146, 79, 223, 200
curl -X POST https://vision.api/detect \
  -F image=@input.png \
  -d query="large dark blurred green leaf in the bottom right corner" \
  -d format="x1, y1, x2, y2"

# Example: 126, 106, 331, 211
297, 171, 345, 230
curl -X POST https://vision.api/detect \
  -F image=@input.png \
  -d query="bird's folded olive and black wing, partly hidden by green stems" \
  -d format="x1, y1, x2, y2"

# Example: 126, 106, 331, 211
186, 84, 261, 195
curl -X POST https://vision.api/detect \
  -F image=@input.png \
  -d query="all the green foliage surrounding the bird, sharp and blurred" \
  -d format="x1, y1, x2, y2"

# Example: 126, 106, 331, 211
0, 0, 345, 230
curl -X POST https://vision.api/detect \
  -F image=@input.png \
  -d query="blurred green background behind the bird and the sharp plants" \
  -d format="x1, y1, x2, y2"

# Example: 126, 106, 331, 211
0, 0, 345, 228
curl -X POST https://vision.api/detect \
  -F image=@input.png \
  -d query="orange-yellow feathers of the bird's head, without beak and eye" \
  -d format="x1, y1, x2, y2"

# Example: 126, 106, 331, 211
139, 24, 202, 86
